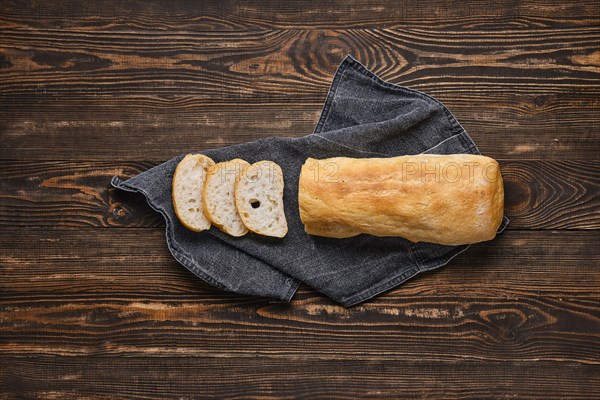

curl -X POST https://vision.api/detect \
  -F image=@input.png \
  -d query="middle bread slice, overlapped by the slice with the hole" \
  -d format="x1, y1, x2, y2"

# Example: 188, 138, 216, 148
202, 158, 250, 237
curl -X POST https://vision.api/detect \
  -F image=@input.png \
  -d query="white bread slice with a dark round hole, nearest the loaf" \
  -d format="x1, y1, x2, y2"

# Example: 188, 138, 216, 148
235, 161, 288, 238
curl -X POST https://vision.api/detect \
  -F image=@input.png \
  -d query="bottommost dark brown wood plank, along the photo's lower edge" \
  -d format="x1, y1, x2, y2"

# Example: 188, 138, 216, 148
0, 355, 600, 400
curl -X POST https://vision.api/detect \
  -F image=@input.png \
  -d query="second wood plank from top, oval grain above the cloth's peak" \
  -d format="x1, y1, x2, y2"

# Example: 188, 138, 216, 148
0, 27, 600, 99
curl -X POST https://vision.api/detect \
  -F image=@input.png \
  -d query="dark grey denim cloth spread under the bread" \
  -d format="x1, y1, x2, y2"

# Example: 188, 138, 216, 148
112, 56, 508, 306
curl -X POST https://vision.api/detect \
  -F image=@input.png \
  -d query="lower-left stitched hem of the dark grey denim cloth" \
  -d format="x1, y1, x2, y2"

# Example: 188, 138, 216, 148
110, 176, 300, 302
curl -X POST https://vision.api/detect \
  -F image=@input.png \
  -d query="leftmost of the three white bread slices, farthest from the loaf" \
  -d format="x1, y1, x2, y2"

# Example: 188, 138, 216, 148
172, 154, 215, 232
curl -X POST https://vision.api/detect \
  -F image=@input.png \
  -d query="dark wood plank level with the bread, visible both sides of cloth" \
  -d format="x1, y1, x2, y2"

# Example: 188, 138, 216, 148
0, 160, 600, 229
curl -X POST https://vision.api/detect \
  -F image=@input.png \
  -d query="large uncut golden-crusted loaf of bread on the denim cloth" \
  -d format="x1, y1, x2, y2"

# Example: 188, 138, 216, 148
298, 154, 504, 245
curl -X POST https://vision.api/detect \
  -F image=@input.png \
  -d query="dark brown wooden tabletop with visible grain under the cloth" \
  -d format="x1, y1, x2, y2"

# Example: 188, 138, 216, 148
0, 0, 600, 399
